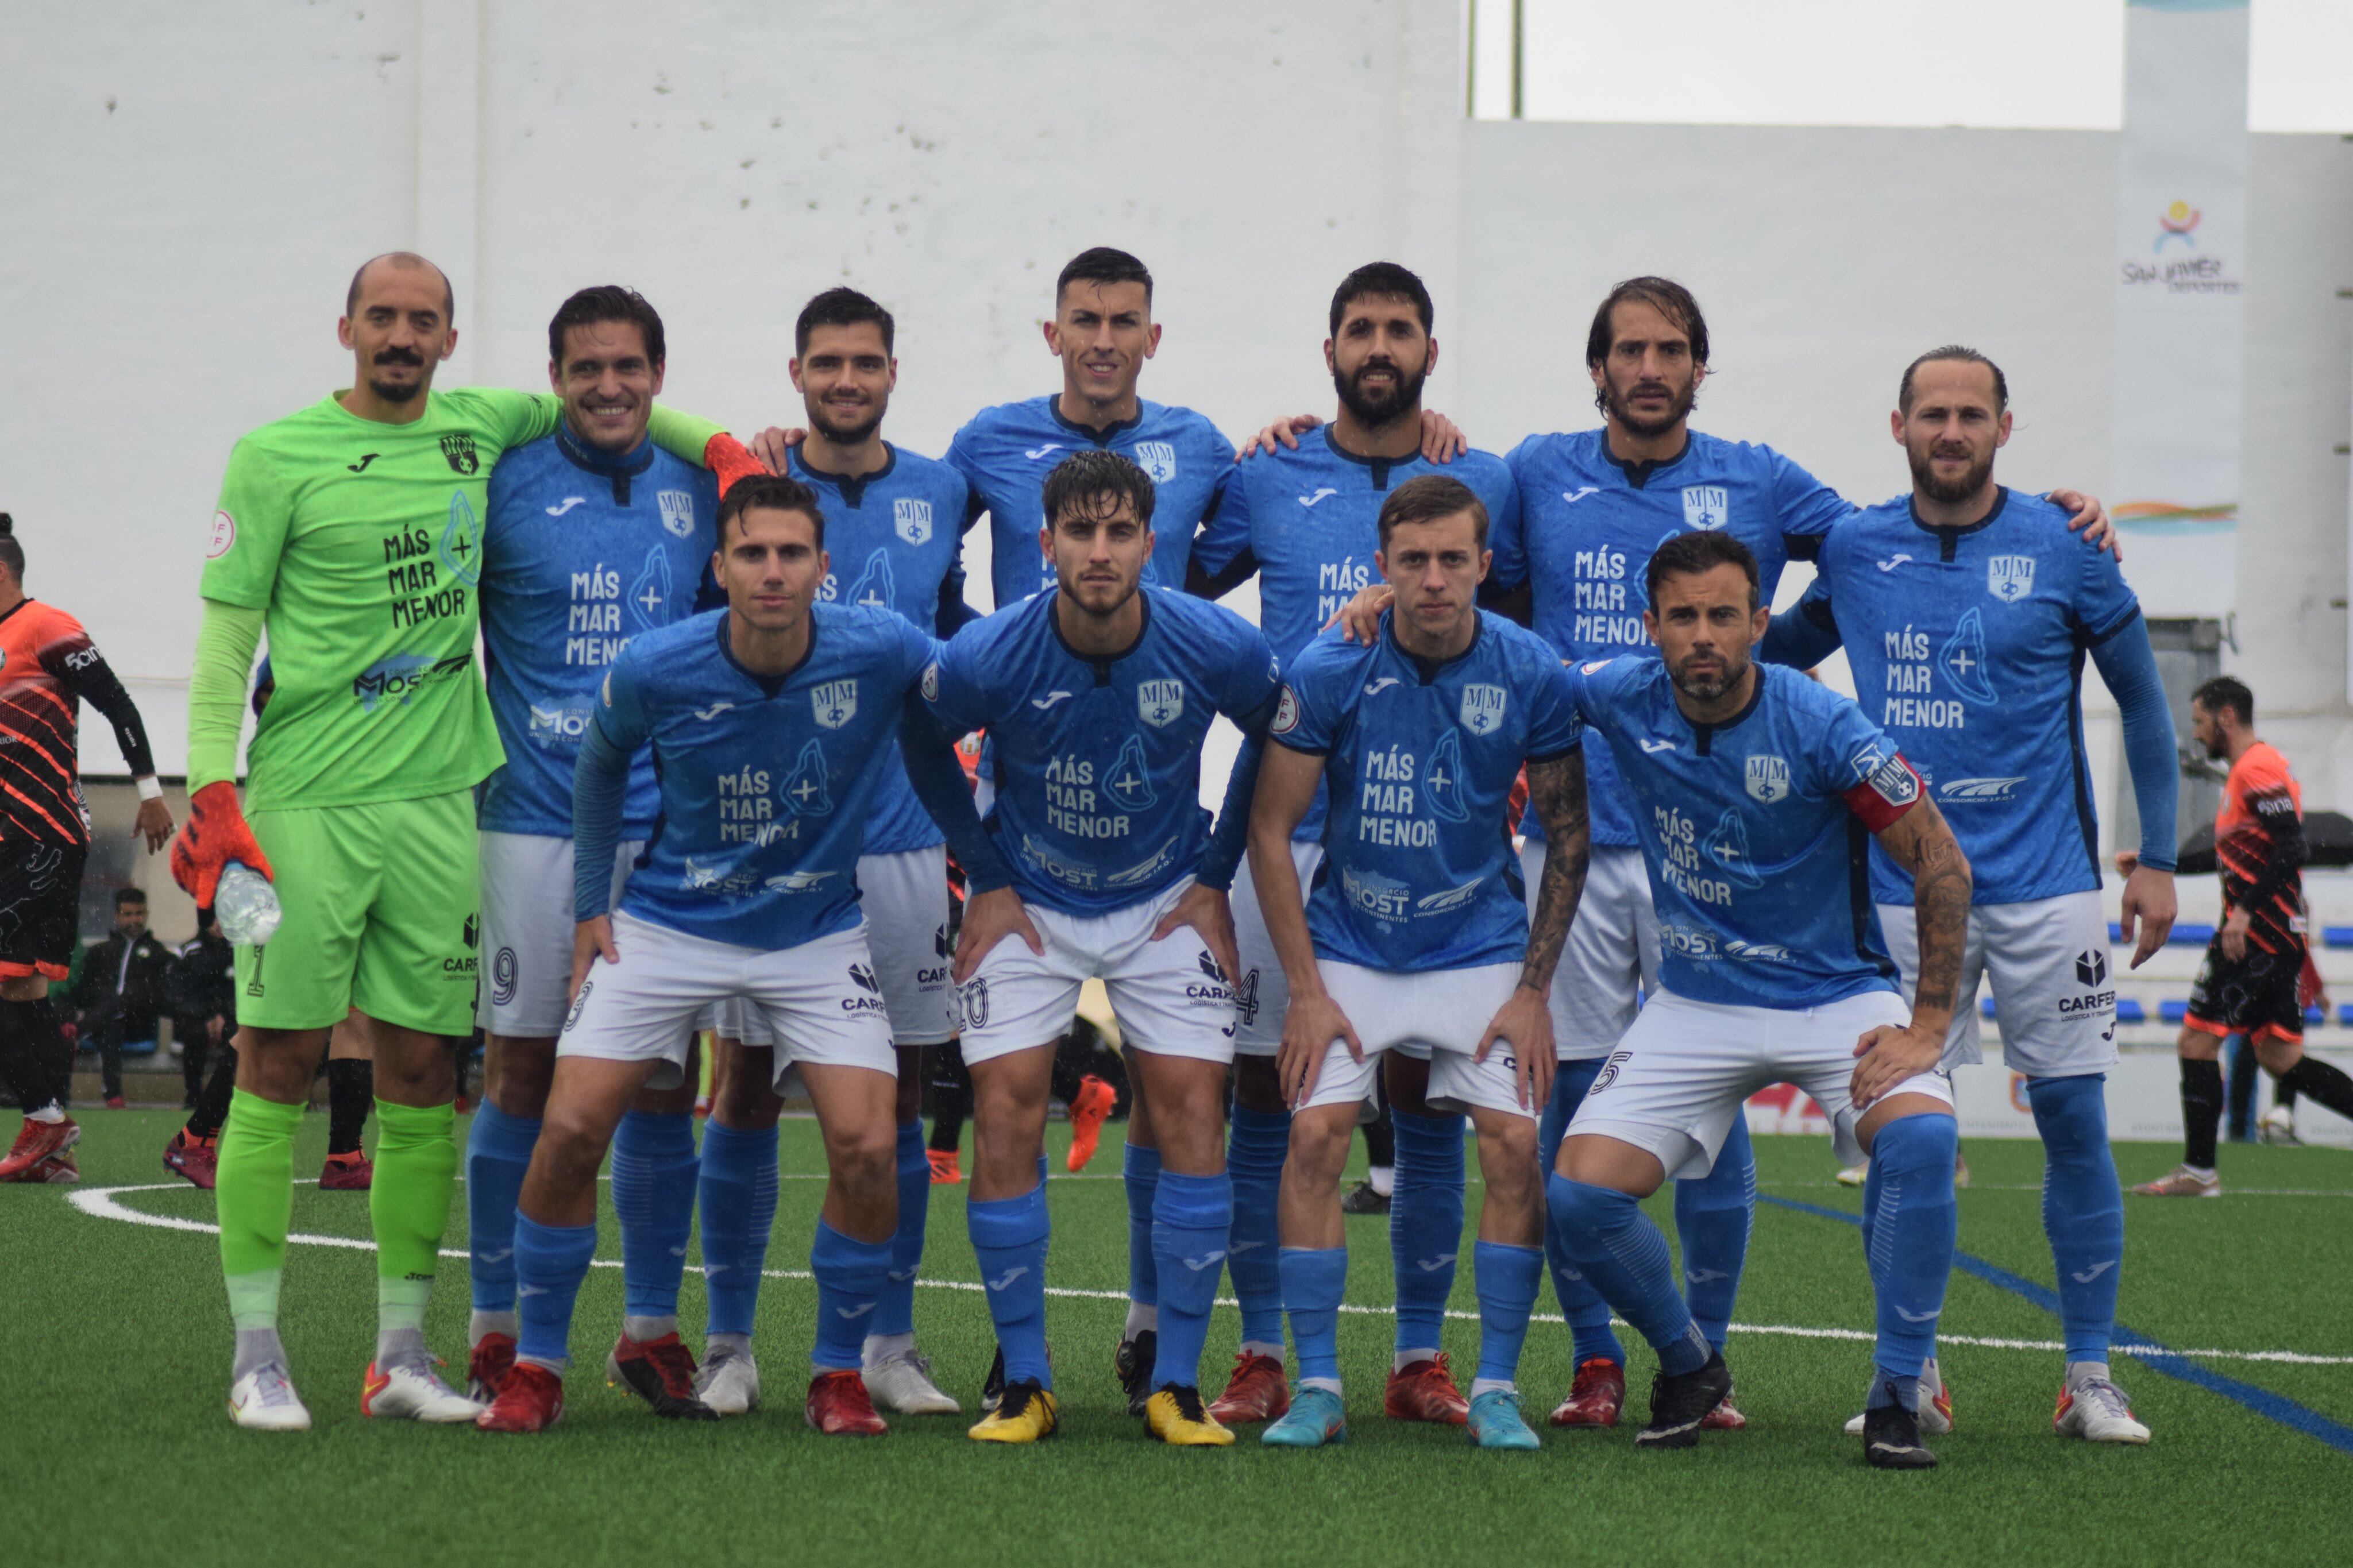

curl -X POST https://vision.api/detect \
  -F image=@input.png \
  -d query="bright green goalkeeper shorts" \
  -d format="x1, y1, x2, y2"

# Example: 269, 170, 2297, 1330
238, 790, 483, 1034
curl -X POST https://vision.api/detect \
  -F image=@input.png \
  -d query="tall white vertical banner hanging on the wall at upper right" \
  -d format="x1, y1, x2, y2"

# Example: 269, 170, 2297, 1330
2106, 0, 2247, 618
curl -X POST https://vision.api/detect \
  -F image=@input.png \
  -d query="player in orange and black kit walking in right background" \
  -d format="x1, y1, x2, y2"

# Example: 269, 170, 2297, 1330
2134, 675, 2353, 1196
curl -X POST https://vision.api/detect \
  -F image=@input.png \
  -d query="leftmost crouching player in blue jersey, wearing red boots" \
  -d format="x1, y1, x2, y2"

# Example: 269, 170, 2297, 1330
480, 477, 979, 1434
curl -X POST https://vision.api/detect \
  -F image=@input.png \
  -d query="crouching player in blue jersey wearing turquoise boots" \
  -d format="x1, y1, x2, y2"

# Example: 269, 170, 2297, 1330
1249, 475, 1586, 1448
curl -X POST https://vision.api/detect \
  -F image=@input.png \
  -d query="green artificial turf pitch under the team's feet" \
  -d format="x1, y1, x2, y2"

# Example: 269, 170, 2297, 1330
18, 1110, 2353, 1568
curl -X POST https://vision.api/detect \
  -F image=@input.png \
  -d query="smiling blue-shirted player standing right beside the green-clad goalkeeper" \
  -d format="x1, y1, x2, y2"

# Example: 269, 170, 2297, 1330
466, 287, 718, 1418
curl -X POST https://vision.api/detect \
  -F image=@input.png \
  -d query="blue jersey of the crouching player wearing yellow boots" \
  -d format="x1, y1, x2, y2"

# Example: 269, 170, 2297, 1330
923, 588, 1280, 914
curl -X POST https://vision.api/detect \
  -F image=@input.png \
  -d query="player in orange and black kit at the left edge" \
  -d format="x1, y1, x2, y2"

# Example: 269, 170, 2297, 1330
0, 512, 172, 1183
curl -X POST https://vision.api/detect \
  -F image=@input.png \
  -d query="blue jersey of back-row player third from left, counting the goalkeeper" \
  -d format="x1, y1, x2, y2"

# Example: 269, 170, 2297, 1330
790, 447, 967, 856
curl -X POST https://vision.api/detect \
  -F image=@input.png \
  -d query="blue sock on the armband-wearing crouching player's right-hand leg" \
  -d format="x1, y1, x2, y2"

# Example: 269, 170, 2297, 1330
1868, 1114, 1960, 1377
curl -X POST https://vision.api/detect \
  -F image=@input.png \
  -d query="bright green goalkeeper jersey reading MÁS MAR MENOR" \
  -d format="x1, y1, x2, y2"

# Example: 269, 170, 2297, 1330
202, 388, 720, 811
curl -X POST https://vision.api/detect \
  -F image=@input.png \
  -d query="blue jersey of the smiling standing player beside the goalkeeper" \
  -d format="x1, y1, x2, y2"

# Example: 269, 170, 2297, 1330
480, 428, 720, 839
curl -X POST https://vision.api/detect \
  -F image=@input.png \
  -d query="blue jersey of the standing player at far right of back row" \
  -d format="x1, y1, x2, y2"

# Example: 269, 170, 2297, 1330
1795, 489, 2141, 903
